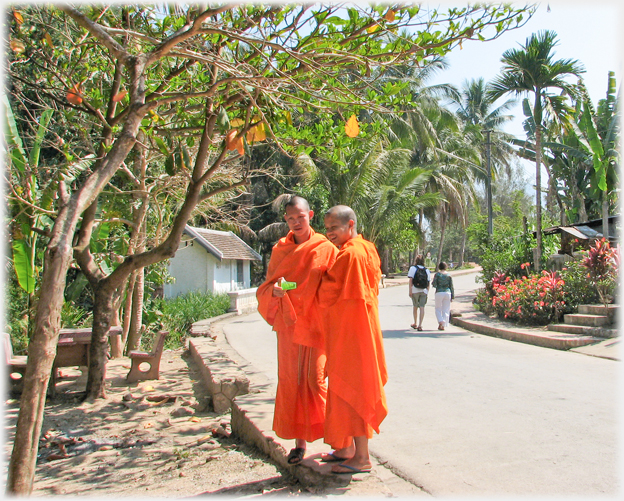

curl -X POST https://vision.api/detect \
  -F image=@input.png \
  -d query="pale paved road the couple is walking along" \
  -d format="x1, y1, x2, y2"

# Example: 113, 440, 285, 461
225, 274, 620, 496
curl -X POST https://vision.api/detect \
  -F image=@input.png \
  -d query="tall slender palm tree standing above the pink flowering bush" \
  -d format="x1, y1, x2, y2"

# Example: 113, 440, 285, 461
489, 30, 585, 271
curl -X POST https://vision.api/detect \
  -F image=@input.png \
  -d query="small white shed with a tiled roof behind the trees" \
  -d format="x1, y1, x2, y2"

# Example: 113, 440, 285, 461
164, 225, 262, 298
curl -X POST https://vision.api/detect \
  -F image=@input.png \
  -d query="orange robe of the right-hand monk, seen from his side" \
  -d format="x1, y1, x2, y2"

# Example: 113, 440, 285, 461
318, 235, 388, 449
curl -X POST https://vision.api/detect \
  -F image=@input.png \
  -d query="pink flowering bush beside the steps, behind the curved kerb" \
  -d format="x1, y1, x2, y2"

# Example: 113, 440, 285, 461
492, 264, 566, 325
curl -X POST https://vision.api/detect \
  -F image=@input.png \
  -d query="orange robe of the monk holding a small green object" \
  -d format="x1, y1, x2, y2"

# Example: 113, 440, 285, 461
256, 230, 338, 442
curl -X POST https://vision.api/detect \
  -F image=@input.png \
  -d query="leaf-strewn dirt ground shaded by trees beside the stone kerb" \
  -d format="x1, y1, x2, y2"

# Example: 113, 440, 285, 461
3, 349, 310, 497
